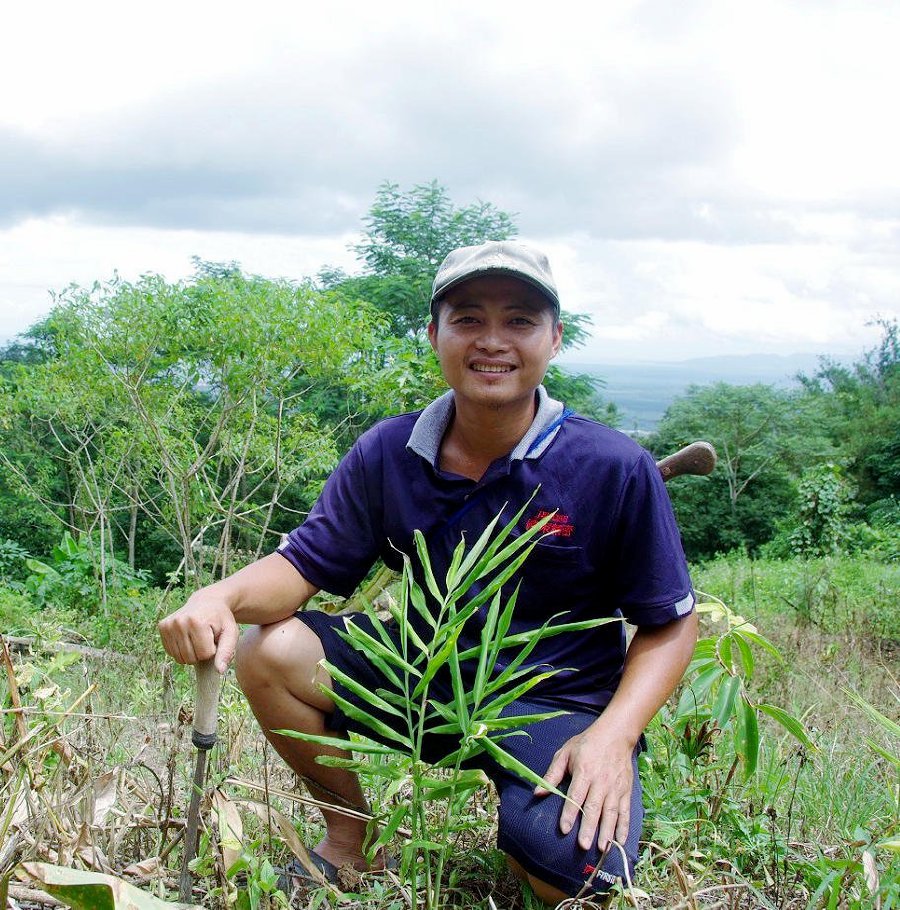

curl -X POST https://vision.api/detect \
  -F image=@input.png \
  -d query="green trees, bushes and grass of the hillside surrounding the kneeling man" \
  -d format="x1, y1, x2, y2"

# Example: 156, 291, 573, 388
0, 184, 900, 910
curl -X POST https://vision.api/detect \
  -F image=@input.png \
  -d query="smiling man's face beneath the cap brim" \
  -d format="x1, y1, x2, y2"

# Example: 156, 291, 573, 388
428, 275, 562, 409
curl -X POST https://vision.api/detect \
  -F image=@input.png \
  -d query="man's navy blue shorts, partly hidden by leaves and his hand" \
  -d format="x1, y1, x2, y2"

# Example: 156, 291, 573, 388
296, 610, 644, 895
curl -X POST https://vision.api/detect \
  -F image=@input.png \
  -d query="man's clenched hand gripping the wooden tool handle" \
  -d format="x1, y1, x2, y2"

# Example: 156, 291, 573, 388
159, 588, 238, 673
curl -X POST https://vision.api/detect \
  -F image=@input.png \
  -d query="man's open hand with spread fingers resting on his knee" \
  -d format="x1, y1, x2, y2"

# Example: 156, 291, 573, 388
534, 721, 634, 850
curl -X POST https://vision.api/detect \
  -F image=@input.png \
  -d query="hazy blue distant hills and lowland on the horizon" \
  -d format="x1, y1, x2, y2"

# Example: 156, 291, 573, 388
560, 354, 832, 432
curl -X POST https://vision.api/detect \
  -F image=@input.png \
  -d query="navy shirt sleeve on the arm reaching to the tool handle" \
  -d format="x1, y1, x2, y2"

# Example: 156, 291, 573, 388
278, 434, 383, 597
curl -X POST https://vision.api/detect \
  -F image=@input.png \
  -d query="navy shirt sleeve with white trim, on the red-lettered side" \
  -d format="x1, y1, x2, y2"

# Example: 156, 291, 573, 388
613, 452, 694, 626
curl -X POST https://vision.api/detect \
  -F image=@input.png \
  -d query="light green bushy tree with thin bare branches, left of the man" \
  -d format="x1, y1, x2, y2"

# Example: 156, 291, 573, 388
0, 269, 383, 580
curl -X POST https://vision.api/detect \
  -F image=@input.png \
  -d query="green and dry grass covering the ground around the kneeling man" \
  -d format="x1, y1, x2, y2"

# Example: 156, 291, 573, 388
0, 557, 900, 910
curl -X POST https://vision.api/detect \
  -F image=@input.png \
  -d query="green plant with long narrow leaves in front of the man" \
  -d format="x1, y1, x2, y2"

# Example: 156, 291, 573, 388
281, 505, 617, 908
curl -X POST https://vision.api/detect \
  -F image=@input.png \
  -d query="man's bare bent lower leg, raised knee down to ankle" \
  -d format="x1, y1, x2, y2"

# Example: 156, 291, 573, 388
235, 617, 368, 869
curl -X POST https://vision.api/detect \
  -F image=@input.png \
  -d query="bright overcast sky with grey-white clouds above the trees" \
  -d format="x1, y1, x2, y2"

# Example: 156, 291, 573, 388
0, 0, 900, 362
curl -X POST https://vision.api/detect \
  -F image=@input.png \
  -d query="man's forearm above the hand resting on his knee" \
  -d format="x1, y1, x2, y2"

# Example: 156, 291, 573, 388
597, 613, 698, 747
